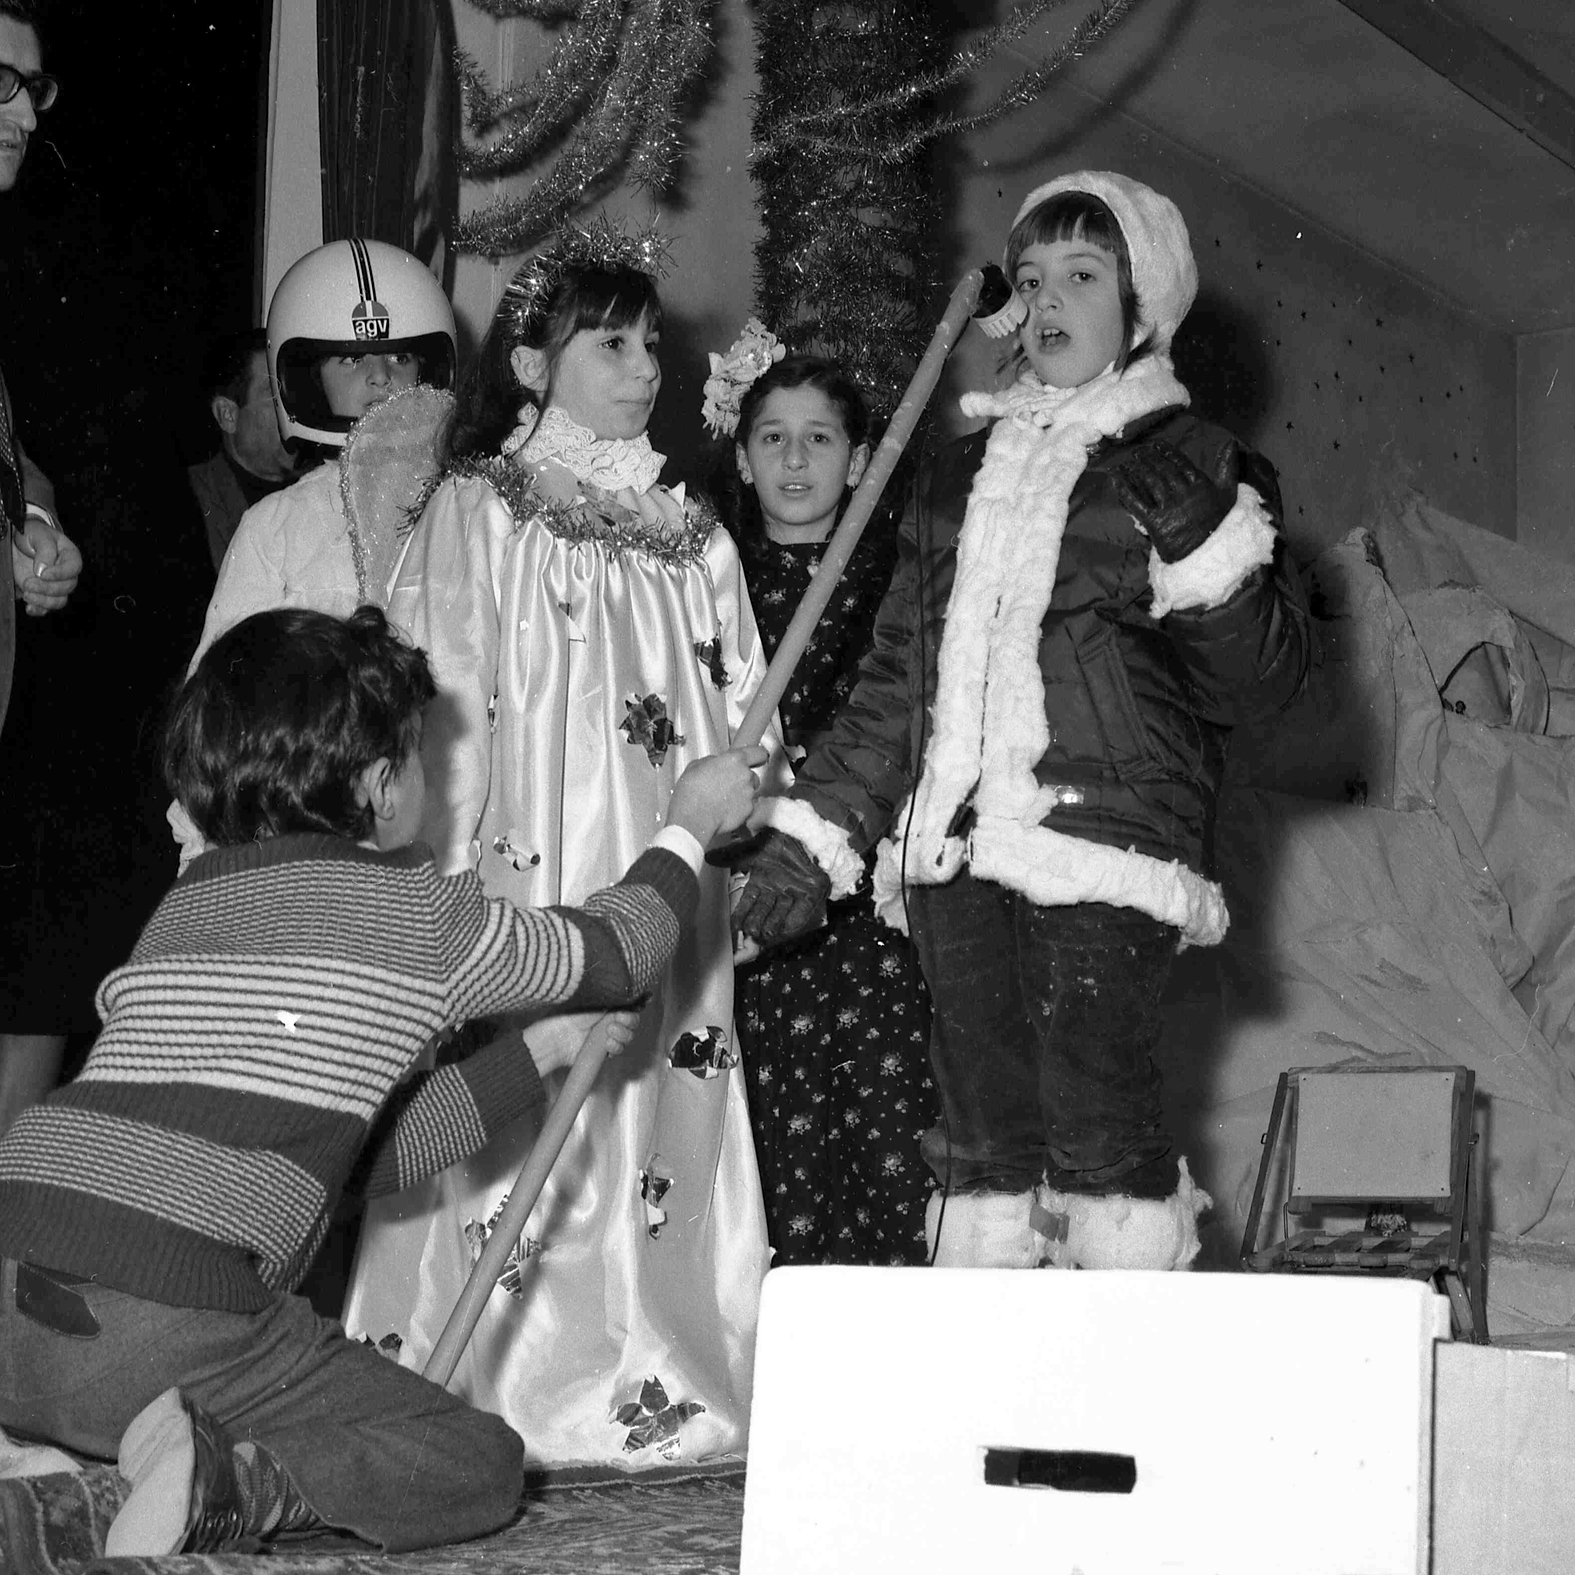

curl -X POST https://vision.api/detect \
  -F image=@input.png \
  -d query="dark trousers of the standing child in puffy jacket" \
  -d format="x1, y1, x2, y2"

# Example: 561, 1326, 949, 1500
907, 869, 1177, 1197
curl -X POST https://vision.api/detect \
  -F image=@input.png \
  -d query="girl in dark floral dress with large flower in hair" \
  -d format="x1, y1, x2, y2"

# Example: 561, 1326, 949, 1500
711, 353, 937, 1266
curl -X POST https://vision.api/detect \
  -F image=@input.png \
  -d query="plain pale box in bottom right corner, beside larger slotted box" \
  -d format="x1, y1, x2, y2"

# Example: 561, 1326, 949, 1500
1433, 1343, 1575, 1575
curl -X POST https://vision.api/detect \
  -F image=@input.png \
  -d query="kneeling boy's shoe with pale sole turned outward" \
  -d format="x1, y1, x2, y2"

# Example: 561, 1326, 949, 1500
104, 1389, 266, 1558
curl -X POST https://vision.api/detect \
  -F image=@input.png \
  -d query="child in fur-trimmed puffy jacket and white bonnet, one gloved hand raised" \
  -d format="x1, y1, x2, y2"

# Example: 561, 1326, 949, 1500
734, 172, 1309, 1268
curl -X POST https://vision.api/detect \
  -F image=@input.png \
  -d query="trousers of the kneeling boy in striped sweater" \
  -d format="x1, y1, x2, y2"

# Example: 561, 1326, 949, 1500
0, 1258, 523, 1553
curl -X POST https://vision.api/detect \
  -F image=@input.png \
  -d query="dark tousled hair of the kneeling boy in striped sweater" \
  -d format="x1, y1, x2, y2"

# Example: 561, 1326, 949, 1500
164, 606, 436, 846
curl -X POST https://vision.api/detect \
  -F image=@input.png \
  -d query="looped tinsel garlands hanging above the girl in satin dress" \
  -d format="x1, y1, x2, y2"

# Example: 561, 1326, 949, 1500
455, 0, 715, 257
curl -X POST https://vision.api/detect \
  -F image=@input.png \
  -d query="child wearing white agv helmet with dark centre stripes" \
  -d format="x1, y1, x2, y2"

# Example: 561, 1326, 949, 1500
192, 239, 455, 666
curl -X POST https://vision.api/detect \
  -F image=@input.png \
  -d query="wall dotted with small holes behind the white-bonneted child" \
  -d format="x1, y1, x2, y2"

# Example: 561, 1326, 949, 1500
954, 91, 1515, 554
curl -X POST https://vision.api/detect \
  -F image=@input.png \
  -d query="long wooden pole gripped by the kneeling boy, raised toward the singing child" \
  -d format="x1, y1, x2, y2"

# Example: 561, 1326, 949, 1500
422, 268, 1010, 1386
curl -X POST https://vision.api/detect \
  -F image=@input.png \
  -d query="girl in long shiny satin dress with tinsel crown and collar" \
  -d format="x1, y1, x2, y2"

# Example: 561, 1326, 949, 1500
345, 254, 780, 1469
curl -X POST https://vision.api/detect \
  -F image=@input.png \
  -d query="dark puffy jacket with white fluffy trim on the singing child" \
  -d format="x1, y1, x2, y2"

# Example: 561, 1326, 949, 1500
774, 381, 1307, 943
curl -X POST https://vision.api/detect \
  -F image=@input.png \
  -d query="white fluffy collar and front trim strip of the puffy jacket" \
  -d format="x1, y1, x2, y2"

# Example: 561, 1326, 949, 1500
907, 354, 1189, 882
